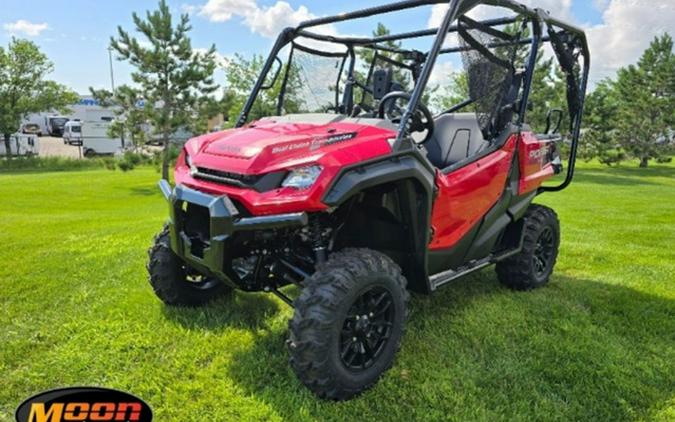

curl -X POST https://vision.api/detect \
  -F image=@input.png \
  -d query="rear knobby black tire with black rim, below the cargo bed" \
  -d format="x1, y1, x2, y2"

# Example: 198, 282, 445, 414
496, 204, 560, 290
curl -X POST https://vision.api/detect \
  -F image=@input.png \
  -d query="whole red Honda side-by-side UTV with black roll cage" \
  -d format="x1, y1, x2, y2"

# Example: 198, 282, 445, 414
148, 0, 589, 400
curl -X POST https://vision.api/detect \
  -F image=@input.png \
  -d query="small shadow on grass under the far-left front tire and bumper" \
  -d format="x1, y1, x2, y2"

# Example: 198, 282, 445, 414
163, 292, 279, 332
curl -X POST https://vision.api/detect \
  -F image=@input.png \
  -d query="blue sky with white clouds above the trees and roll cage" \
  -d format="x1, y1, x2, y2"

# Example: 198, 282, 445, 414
0, 0, 675, 94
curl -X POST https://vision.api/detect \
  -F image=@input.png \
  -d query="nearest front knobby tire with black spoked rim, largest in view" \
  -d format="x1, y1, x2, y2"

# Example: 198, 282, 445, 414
288, 249, 410, 400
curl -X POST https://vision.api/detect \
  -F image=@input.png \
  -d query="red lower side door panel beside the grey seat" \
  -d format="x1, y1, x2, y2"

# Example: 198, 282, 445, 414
429, 135, 518, 250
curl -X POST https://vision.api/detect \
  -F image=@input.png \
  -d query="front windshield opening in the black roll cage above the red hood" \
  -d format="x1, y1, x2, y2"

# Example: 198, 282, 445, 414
249, 37, 423, 120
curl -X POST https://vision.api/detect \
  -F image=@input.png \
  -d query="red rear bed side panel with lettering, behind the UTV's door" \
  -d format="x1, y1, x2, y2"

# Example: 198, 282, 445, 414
518, 132, 554, 195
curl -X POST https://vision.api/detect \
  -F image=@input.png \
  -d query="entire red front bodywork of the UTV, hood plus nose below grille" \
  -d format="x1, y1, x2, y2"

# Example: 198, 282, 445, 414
175, 120, 396, 215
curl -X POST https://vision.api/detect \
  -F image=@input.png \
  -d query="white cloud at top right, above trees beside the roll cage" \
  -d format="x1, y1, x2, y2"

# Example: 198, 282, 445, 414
586, 0, 675, 82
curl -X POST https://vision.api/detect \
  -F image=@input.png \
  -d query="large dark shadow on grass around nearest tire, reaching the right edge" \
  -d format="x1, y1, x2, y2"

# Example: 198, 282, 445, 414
228, 271, 675, 420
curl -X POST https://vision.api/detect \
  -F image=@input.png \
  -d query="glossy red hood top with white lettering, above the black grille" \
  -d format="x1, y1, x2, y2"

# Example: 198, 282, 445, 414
186, 120, 395, 174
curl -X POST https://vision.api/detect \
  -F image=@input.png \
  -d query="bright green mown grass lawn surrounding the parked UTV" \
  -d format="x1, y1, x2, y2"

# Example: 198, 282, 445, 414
0, 165, 675, 421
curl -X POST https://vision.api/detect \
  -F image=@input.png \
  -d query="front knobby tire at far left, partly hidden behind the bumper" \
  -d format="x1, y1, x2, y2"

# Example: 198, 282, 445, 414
147, 226, 232, 307
